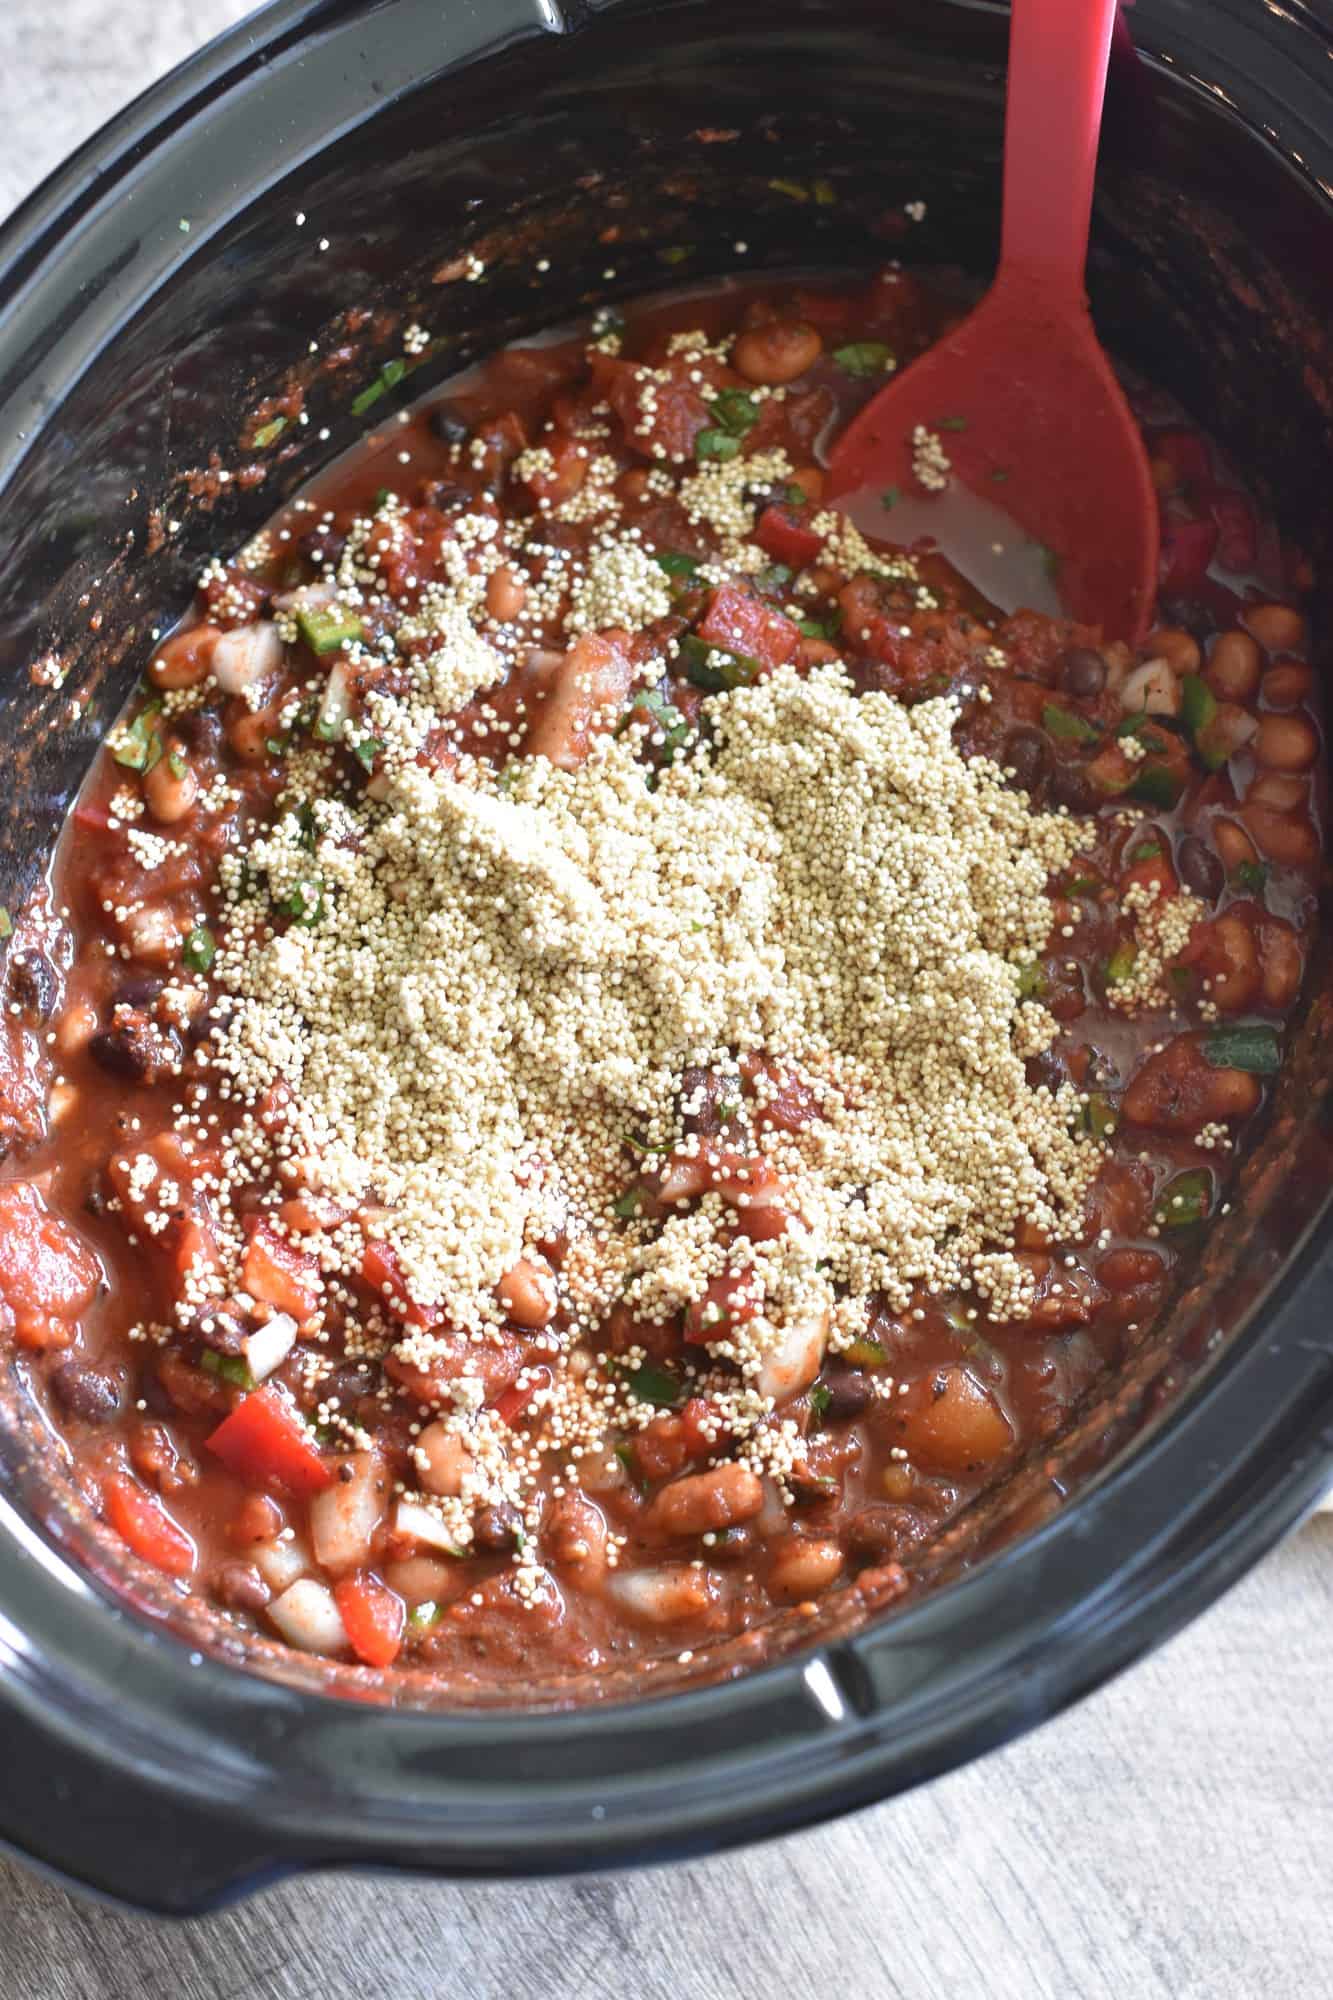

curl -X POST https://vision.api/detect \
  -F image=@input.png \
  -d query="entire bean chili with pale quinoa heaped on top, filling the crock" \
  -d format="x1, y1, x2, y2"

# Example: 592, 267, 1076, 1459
0, 270, 1319, 1696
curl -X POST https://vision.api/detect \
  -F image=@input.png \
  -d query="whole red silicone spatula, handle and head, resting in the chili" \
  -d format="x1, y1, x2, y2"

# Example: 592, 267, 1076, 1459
829, 0, 1159, 640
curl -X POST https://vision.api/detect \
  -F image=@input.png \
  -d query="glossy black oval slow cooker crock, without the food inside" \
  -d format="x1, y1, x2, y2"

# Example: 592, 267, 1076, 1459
0, 0, 1333, 1910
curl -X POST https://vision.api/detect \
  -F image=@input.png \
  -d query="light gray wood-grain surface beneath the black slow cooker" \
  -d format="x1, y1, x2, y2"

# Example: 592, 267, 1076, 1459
0, 0, 1333, 2000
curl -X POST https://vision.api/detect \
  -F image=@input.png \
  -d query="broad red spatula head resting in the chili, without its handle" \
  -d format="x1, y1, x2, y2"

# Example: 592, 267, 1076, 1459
829, 278, 1159, 642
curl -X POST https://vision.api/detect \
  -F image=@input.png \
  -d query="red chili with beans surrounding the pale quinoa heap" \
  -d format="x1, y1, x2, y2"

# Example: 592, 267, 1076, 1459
0, 274, 1321, 1694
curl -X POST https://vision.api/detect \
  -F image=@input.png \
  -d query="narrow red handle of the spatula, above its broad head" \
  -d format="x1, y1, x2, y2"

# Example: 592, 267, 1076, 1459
1001, 0, 1117, 300
